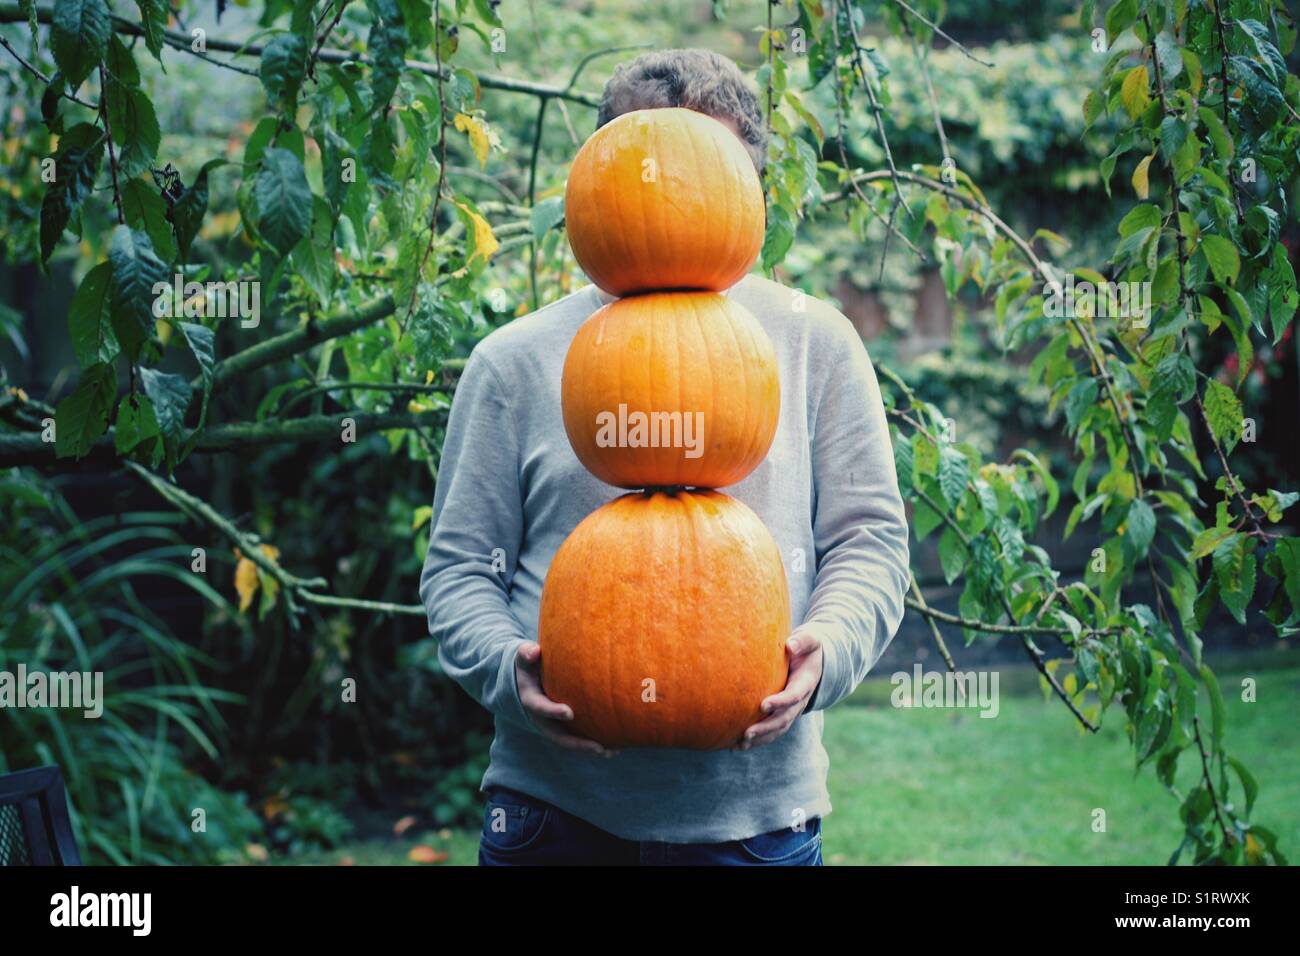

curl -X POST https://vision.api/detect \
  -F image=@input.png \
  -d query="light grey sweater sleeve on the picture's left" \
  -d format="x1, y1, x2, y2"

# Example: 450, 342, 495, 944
420, 349, 533, 728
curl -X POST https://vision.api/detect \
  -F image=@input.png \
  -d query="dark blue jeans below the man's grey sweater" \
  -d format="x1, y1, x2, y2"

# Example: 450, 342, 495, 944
478, 787, 822, 866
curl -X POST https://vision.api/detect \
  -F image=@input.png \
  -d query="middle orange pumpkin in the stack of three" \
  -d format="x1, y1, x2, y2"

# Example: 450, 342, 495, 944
560, 293, 781, 488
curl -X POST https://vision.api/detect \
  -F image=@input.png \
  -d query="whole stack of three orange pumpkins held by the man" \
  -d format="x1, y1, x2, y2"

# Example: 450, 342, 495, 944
538, 109, 790, 749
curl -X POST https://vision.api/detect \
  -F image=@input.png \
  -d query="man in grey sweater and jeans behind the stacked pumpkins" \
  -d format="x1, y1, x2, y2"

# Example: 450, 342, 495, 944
420, 49, 909, 865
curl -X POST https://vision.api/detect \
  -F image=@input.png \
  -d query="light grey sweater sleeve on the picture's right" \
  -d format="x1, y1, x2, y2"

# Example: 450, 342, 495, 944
800, 320, 910, 710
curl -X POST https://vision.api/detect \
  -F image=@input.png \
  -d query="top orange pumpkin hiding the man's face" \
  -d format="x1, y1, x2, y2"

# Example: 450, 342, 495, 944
564, 107, 766, 295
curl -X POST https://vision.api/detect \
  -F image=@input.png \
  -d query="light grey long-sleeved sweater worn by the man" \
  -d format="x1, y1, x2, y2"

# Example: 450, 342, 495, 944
420, 274, 909, 843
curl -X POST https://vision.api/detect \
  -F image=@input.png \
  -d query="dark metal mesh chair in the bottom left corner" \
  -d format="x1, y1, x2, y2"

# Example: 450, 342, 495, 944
0, 766, 81, 866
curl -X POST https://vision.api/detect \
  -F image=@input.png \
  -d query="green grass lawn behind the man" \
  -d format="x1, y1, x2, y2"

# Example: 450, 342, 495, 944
294, 662, 1300, 866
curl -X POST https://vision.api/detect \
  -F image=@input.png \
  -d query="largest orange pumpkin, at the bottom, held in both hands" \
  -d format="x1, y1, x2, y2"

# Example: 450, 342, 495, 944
538, 492, 790, 750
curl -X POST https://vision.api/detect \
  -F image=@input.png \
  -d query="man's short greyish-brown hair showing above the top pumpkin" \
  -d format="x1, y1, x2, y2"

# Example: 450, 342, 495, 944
595, 49, 767, 172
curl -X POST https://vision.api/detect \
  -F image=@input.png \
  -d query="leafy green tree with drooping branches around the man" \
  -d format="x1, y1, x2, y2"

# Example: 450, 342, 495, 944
0, 0, 1300, 864
